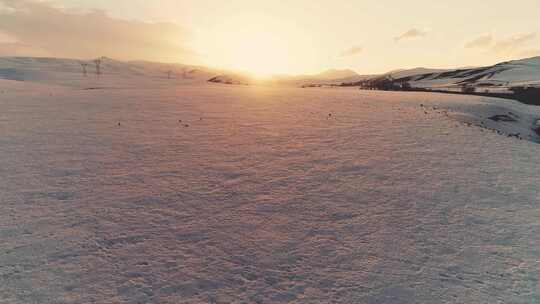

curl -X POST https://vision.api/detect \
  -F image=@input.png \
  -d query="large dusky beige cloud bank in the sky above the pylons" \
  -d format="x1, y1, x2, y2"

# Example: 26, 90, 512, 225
0, 0, 195, 61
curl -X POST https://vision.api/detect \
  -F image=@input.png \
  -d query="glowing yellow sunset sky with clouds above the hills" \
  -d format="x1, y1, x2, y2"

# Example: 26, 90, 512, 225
0, 0, 540, 74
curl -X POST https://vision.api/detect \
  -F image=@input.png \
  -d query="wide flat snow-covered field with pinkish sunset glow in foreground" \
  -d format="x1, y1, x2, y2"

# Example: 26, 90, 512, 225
0, 80, 540, 304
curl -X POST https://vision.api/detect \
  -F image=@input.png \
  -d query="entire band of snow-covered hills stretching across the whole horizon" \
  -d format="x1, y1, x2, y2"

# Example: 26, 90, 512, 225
0, 57, 540, 93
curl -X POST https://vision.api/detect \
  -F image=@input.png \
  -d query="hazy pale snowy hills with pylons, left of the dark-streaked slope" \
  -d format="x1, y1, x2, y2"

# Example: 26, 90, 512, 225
0, 57, 369, 87
